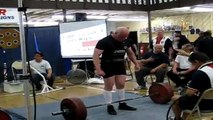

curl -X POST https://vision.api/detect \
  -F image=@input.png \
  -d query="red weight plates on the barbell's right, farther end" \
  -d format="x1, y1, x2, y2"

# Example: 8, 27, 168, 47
149, 83, 173, 104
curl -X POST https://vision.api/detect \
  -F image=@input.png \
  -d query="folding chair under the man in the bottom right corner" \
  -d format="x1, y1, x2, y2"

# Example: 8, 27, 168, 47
183, 88, 213, 120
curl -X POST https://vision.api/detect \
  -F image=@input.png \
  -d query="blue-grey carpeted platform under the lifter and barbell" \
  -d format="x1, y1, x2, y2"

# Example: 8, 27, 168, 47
9, 93, 169, 120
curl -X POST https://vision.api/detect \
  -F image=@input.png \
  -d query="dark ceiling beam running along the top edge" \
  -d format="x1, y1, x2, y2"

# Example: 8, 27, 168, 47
0, 0, 213, 11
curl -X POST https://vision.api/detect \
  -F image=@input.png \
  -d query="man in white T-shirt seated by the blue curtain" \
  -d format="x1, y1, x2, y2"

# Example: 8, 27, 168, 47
30, 52, 55, 90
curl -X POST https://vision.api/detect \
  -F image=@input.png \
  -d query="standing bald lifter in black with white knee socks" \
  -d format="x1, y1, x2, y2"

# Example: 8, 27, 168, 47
93, 27, 140, 115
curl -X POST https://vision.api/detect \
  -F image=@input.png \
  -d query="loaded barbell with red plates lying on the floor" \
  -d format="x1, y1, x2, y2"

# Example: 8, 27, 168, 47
52, 83, 174, 120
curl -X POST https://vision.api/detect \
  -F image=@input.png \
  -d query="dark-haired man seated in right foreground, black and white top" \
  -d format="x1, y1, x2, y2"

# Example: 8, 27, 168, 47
172, 52, 213, 120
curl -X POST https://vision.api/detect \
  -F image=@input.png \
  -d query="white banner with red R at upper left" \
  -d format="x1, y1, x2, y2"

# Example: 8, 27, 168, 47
0, 8, 19, 24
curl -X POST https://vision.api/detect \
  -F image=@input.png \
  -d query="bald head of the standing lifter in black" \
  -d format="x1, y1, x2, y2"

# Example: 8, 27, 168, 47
113, 27, 129, 41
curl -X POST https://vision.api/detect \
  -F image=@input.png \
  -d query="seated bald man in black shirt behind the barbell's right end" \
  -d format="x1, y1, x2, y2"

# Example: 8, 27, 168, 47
135, 44, 169, 89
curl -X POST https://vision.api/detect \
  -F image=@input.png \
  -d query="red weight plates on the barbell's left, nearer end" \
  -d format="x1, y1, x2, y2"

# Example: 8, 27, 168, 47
61, 98, 87, 120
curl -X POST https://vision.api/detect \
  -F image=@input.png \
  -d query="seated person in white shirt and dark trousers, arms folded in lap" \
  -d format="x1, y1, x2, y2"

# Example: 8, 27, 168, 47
167, 43, 194, 87
